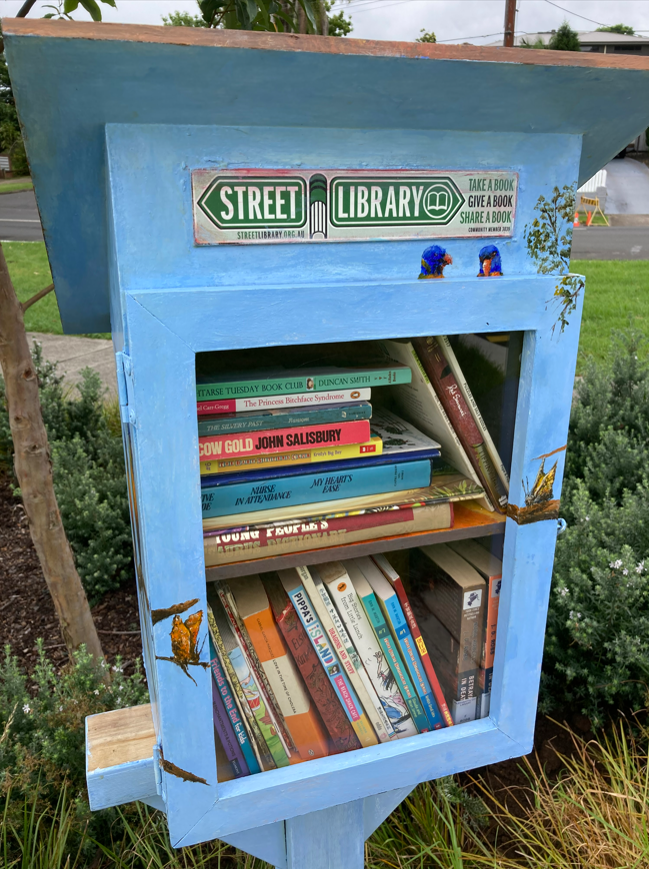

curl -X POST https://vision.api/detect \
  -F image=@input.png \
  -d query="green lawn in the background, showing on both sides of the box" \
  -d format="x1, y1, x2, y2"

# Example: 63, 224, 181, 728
2, 241, 649, 358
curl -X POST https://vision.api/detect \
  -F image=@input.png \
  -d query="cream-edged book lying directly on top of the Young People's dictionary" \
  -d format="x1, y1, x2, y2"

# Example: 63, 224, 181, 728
203, 474, 483, 531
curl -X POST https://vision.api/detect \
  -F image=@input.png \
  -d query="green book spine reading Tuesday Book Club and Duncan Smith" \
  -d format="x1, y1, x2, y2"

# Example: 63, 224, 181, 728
196, 365, 412, 401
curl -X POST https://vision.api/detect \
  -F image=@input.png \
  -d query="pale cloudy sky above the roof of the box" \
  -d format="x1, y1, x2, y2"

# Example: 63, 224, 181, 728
0, 0, 649, 44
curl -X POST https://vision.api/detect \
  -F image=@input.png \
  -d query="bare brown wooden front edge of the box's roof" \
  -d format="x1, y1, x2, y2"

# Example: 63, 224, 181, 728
2, 18, 649, 70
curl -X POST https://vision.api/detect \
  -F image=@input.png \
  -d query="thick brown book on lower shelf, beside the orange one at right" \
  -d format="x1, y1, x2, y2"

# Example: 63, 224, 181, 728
410, 544, 486, 724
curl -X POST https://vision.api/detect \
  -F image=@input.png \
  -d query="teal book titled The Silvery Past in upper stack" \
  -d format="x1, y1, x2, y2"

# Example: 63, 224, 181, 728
198, 401, 372, 437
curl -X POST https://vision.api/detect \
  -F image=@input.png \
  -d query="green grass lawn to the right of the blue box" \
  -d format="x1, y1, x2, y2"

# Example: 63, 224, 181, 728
570, 260, 649, 372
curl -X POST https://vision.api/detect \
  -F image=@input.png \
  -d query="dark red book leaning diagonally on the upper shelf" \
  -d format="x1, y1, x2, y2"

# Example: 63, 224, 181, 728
414, 337, 507, 511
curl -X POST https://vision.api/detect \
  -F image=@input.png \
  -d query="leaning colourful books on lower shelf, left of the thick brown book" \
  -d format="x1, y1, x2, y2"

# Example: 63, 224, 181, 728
208, 556, 453, 780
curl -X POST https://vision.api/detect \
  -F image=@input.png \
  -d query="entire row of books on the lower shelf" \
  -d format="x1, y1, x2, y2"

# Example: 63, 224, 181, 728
207, 540, 502, 781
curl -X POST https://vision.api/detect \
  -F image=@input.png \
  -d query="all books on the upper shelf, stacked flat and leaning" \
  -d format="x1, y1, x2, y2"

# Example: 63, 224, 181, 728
197, 339, 498, 567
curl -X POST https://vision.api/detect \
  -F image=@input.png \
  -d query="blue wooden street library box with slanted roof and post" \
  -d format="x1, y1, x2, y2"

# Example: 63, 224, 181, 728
3, 19, 649, 869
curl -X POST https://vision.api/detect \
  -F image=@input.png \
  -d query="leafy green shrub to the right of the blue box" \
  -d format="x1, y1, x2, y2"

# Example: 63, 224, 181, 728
541, 333, 649, 725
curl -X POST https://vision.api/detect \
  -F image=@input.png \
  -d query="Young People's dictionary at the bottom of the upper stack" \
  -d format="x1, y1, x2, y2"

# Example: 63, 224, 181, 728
203, 503, 453, 568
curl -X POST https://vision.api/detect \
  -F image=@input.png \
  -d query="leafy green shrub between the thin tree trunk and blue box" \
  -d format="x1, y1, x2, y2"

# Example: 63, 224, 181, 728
0, 344, 134, 605
